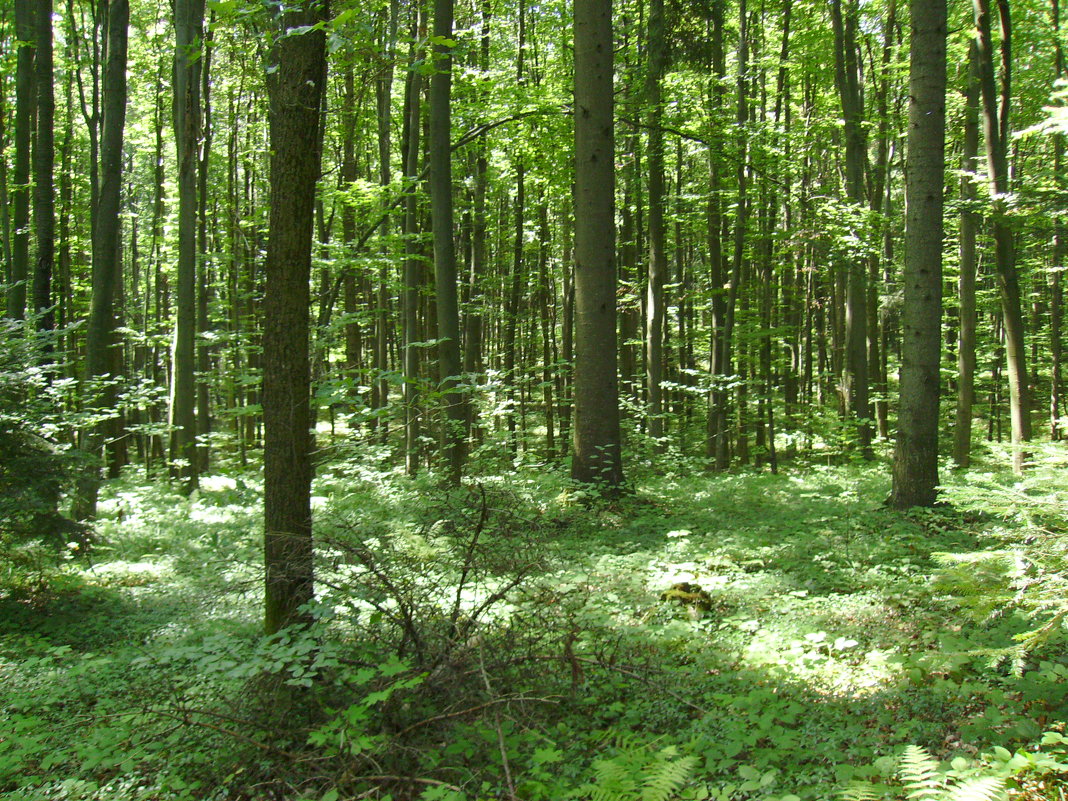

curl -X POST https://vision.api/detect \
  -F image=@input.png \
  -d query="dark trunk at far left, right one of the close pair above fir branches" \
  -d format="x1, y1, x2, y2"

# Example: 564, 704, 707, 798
33, 0, 56, 339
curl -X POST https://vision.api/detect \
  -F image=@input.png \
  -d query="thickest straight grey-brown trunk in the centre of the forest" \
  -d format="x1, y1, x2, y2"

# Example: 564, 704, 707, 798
571, 0, 623, 491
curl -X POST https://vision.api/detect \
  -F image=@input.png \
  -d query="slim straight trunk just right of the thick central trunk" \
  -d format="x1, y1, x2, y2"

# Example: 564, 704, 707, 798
645, 0, 677, 445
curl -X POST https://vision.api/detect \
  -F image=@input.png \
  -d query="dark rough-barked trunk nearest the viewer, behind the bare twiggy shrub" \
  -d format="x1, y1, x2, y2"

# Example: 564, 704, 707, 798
263, 0, 327, 633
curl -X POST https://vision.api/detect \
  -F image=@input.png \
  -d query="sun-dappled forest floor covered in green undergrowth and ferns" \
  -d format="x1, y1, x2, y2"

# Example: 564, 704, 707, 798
0, 446, 1068, 801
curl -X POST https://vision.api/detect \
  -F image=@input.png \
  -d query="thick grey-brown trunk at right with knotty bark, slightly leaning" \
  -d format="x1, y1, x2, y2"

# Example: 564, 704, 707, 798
890, 0, 946, 508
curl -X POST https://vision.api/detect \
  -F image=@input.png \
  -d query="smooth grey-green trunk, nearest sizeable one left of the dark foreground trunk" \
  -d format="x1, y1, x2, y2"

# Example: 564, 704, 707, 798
171, 0, 204, 492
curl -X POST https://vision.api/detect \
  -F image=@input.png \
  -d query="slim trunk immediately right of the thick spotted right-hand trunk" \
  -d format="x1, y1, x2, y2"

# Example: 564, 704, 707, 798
953, 40, 979, 468
